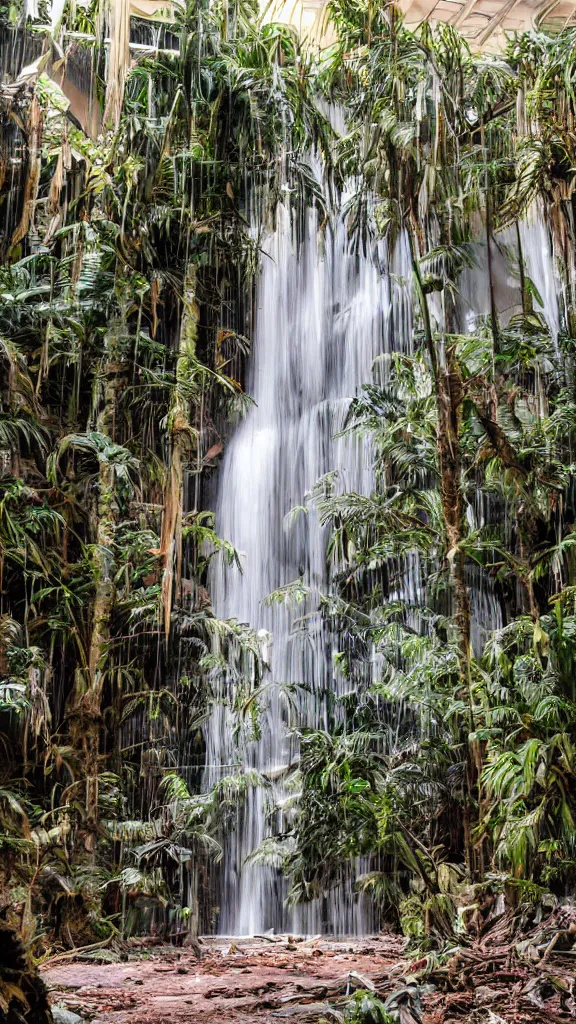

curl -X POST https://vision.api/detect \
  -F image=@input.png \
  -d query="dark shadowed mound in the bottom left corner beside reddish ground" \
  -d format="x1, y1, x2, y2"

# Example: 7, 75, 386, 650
0, 920, 52, 1024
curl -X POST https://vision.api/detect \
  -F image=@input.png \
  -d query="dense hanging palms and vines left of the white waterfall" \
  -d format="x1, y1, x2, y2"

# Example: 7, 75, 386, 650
0, 3, 329, 974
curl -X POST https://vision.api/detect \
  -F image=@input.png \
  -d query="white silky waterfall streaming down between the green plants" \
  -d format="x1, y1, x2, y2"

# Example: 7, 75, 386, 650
205, 195, 558, 935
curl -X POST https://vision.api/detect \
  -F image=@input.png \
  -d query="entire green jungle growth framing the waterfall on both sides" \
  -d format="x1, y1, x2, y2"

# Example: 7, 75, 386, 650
0, 0, 576, 995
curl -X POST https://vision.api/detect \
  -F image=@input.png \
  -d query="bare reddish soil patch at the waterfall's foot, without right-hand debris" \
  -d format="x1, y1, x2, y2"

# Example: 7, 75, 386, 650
43, 936, 406, 1024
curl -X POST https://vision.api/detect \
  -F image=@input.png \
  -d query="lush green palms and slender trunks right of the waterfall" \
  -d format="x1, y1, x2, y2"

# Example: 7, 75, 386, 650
270, 0, 576, 936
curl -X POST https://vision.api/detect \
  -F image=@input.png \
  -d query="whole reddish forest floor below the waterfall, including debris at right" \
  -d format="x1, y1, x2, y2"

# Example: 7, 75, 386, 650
43, 917, 576, 1024
